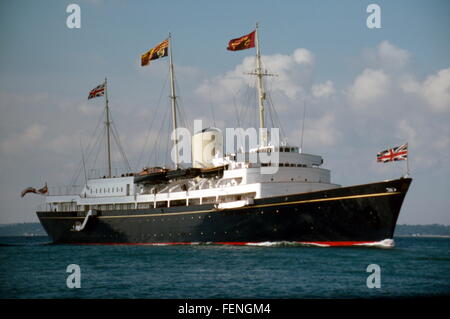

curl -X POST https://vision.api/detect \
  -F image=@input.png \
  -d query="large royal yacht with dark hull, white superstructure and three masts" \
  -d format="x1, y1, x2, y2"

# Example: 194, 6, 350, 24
32, 25, 412, 247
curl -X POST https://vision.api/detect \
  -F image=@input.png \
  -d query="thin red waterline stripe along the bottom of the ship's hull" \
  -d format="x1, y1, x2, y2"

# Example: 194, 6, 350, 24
73, 241, 376, 247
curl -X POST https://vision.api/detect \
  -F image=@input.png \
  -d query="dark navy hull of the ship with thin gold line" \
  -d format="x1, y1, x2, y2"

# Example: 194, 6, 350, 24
37, 178, 411, 245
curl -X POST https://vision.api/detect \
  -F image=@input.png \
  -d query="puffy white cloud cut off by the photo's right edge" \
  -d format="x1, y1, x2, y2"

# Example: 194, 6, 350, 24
402, 68, 450, 112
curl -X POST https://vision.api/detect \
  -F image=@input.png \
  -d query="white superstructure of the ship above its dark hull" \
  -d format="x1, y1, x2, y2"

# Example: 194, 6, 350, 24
46, 146, 339, 211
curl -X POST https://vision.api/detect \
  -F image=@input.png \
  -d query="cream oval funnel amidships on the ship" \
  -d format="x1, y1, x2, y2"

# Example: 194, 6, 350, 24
192, 127, 223, 168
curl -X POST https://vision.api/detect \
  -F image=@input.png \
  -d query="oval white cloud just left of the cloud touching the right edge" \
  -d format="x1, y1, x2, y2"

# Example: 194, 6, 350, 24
347, 69, 390, 108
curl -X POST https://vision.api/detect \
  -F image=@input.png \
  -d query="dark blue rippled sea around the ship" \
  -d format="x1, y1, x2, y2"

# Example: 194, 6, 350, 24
0, 237, 450, 299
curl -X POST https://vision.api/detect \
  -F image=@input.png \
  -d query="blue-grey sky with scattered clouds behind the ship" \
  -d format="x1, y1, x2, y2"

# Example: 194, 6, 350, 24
0, 0, 450, 225
